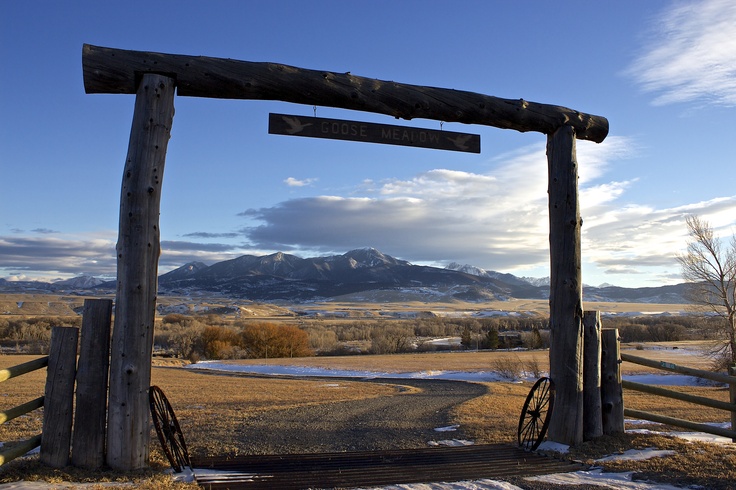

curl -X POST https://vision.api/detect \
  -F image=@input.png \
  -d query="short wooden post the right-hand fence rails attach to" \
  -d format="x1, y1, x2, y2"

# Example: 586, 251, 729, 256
601, 328, 624, 435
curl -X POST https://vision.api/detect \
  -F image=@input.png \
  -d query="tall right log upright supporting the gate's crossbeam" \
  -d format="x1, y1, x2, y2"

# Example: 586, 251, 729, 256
547, 126, 583, 445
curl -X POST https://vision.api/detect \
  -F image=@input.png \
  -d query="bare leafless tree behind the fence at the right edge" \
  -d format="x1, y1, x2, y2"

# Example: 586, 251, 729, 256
677, 216, 736, 367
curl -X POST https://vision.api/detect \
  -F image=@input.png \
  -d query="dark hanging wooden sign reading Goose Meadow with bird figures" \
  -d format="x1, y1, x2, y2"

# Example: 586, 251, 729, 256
268, 113, 480, 153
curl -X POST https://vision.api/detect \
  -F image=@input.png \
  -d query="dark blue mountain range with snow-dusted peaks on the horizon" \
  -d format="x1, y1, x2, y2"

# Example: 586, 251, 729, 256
0, 248, 688, 304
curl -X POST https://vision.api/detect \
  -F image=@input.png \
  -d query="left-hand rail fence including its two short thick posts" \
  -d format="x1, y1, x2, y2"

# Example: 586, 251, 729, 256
0, 299, 112, 469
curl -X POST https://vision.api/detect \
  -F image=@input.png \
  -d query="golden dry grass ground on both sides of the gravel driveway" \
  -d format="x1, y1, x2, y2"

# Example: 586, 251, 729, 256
0, 345, 736, 489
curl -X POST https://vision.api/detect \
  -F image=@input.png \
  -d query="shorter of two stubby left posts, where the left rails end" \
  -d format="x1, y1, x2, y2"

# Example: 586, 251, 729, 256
40, 327, 79, 468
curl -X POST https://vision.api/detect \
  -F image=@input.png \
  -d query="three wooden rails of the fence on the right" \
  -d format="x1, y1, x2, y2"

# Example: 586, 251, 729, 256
621, 354, 736, 442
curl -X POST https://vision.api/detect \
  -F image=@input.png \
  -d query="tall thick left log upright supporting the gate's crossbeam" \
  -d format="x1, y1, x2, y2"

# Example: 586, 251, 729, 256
107, 73, 175, 471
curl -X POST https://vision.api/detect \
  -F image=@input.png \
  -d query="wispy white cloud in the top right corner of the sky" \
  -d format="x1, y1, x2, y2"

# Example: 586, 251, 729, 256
626, 0, 736, 107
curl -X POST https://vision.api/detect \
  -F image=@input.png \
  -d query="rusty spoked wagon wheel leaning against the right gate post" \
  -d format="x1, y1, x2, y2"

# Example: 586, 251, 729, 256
518, 377, 555, 451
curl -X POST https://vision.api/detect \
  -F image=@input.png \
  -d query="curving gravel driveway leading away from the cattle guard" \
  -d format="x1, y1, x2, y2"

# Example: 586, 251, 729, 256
235, 379, 487, 454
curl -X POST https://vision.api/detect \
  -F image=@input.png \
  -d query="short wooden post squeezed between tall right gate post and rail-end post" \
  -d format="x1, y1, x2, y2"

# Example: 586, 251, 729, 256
583, 311, 603, 441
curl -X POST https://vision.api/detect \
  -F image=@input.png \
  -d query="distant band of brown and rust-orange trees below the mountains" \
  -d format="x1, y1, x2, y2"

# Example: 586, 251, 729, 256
0, 314, 721, 360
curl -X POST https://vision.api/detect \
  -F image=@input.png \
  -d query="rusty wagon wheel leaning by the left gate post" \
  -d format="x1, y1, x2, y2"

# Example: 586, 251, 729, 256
148, 386, 192, 473
